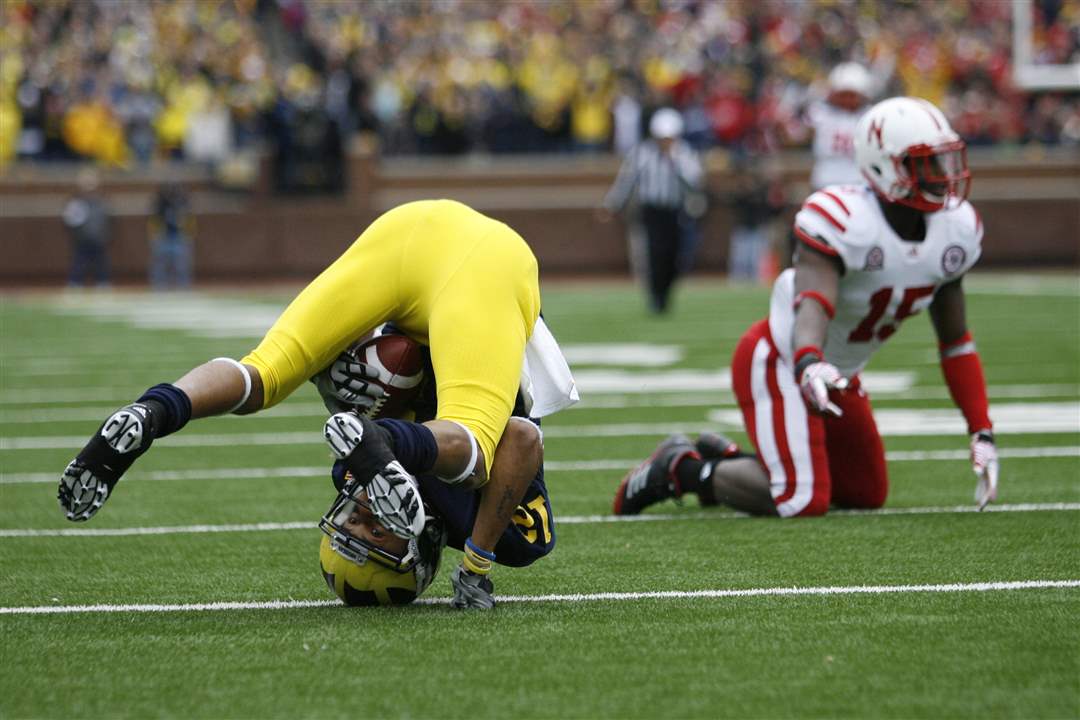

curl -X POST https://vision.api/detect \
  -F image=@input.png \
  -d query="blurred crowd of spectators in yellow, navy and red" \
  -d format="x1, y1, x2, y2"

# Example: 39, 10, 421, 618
0, 0, 1080, 164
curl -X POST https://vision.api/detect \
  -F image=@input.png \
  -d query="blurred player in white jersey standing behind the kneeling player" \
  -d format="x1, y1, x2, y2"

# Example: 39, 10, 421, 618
807, 63, 874, 190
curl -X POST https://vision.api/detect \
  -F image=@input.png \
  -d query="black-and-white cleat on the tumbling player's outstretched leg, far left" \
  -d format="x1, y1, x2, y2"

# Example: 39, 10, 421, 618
56, 403, 153, 521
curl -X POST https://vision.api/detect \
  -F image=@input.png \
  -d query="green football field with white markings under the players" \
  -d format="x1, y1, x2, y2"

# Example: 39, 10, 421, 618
0, 274, 1080, 718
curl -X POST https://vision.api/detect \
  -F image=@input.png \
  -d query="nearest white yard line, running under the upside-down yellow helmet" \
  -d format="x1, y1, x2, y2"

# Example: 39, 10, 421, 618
0, 580, 1080, 615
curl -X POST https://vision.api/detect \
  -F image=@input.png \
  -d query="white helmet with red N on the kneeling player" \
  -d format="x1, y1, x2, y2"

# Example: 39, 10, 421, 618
855, 97, 971, 213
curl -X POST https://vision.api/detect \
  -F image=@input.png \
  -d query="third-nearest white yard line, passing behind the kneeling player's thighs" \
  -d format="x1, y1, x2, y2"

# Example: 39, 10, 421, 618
0, 445, 1080, 485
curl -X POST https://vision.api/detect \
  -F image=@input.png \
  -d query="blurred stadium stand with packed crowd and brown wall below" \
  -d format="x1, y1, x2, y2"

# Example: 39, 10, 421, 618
0, 0, 1080, 284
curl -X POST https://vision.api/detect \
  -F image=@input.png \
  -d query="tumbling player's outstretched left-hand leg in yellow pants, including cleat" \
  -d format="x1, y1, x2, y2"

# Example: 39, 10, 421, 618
58, 206, 417, 520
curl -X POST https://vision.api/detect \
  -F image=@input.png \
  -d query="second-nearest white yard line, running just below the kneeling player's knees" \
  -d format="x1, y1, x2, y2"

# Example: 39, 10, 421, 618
0, 502, 1080, 538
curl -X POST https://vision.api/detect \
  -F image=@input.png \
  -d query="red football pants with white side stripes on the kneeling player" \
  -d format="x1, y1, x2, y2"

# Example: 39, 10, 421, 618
731, 321, 889, 517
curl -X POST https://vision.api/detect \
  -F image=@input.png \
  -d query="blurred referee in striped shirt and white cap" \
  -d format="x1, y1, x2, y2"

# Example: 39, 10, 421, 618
600, 108, 704, 313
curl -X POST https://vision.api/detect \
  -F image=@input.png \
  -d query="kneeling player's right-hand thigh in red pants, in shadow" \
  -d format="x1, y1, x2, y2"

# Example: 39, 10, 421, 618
825, 383, 889, 508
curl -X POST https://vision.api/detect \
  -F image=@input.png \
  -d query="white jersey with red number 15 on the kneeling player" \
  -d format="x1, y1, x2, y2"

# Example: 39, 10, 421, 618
769, 186, 983, 378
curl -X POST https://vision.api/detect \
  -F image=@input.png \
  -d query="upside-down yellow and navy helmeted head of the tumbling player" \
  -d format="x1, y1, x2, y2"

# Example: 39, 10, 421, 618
319, 477, 446, 606
